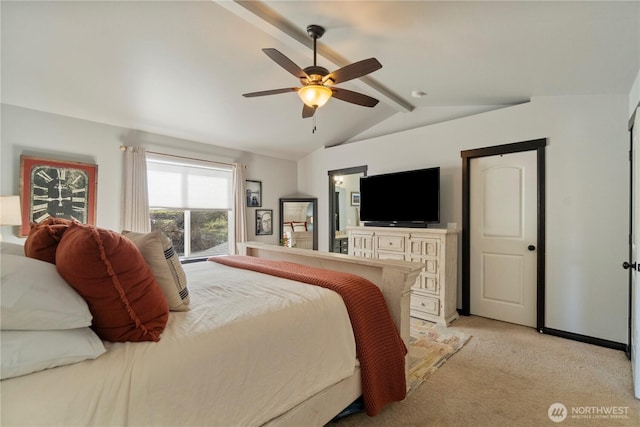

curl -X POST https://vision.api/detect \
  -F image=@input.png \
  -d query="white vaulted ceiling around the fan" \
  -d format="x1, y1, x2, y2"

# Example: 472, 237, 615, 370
0, 0, 640, 159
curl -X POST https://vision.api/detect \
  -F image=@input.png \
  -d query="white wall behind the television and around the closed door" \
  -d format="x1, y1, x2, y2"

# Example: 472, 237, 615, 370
298, 95, 629, 343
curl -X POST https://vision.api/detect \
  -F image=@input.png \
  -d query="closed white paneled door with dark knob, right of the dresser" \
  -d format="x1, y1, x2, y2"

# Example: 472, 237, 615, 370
469, 151, 537, 327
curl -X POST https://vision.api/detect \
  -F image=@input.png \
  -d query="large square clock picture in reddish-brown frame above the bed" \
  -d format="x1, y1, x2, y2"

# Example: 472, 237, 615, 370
20, 156, 98, 236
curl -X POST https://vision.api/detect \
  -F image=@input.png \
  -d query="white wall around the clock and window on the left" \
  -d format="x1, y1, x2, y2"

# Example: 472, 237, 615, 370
0, 104, 297, 244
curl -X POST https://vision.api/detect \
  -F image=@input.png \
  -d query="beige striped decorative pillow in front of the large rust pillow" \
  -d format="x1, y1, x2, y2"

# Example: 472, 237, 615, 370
122, 230, 189, 311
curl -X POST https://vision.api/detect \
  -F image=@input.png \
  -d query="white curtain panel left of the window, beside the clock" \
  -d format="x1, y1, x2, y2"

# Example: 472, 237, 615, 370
120, 147, 151, 233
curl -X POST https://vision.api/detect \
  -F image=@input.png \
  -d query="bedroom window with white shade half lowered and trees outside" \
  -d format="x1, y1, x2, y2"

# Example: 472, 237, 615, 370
147, 155, 233, 258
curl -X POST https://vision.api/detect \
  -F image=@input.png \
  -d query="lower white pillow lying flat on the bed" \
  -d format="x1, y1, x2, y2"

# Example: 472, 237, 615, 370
0, 328, 106, 380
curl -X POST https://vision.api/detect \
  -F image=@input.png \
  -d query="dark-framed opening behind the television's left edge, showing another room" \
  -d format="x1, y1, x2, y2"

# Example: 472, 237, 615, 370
329, 166, 367, 254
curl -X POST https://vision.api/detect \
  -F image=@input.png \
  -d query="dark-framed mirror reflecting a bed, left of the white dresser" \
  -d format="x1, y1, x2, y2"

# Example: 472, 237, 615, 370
280, 197, 318, 250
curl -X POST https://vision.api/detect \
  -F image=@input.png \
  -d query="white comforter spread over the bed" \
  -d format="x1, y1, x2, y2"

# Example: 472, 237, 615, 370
1, 262, 356, 426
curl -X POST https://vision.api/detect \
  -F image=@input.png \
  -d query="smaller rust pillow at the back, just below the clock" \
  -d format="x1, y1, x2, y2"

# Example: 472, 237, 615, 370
24, 217, 73, 264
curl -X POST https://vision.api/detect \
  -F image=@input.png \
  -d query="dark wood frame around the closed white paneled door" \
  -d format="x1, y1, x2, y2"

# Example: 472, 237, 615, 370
460, 138, 547, 332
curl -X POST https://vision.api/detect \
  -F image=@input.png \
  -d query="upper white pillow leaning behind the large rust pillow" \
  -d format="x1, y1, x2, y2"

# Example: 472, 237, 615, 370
0, 253, 92, 330
